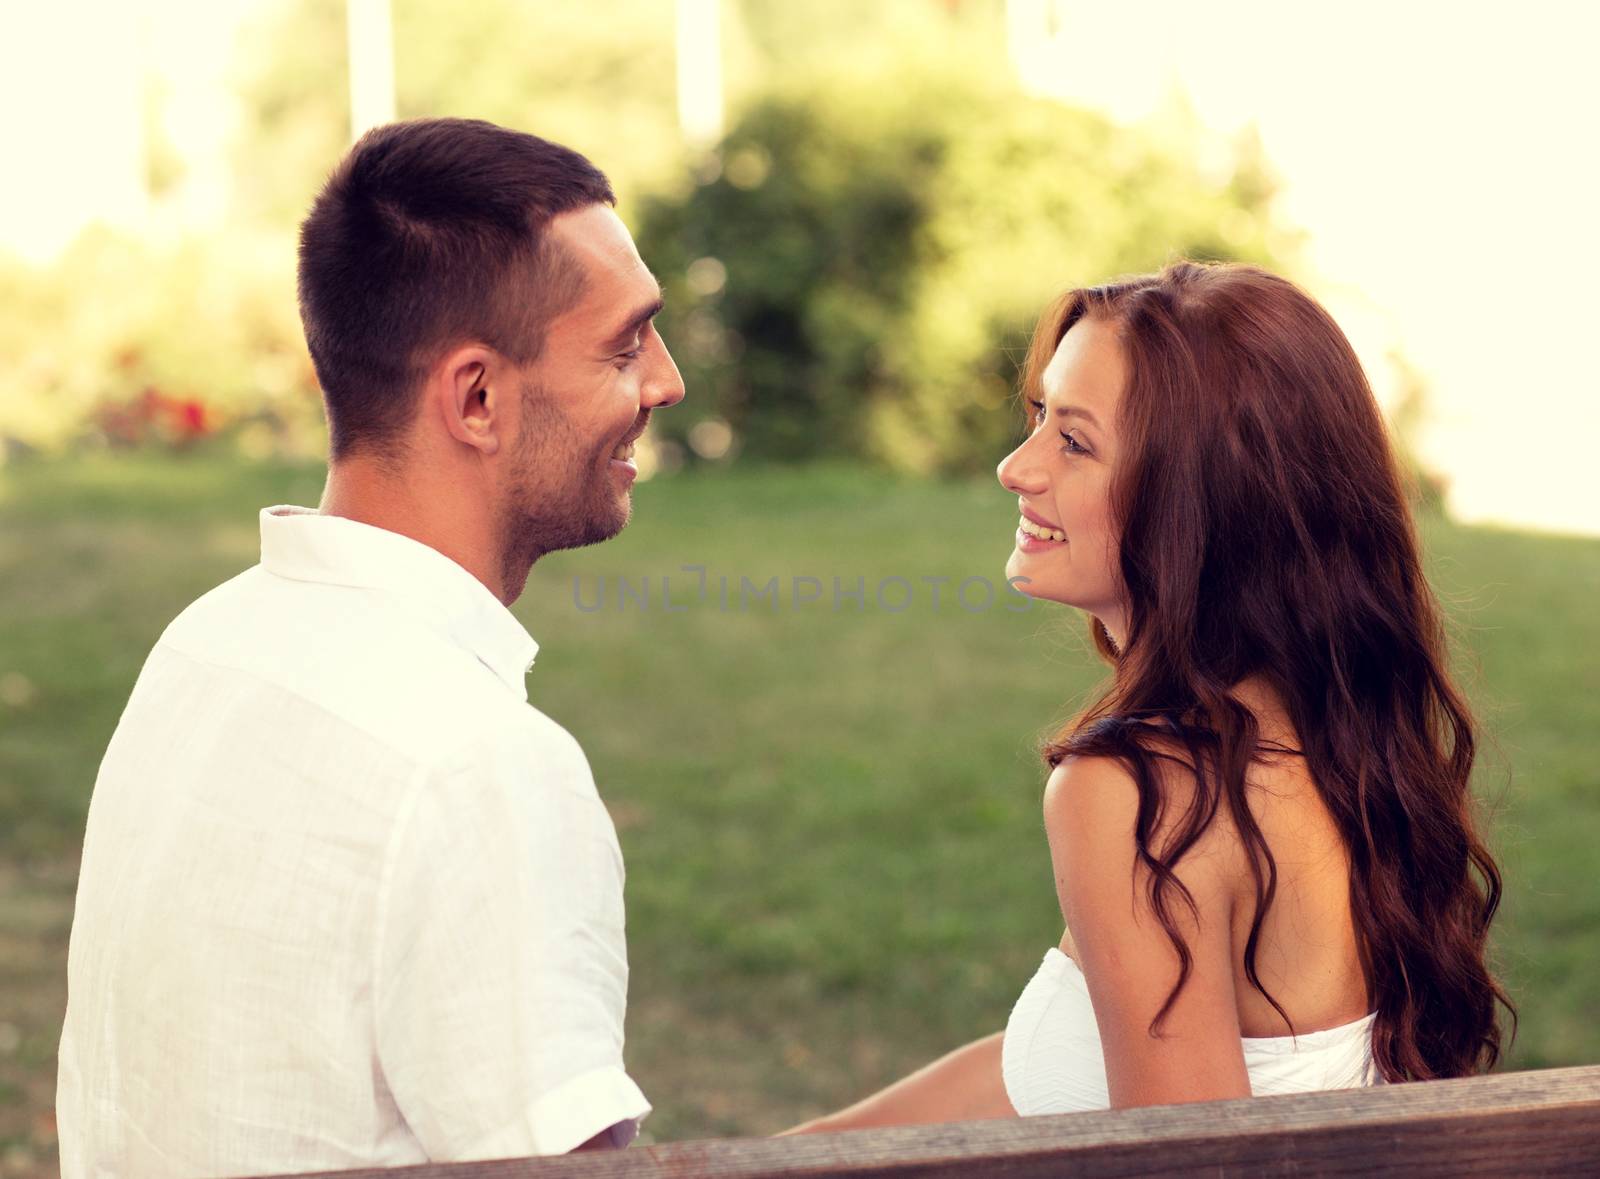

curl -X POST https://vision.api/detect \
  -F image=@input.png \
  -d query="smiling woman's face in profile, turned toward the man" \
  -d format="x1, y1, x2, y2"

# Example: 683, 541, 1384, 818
998, 318, 1128, 633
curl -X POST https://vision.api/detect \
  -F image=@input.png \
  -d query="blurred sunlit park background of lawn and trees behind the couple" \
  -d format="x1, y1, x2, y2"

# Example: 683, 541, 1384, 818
0, 0, 1600, 1176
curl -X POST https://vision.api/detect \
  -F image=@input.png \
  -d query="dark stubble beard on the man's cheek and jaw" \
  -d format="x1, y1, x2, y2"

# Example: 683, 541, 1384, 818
499, 386, 630, 597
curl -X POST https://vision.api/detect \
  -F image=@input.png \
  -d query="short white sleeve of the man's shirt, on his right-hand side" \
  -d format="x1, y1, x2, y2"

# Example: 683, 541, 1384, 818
373, 710, 650, 1161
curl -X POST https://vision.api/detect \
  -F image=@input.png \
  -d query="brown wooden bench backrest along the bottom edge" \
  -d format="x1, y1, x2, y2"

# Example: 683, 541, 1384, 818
272, 1065, 1600, 1179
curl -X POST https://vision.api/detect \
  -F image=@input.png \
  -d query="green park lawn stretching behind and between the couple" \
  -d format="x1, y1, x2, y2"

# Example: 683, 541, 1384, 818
0, 454, 1600, 1173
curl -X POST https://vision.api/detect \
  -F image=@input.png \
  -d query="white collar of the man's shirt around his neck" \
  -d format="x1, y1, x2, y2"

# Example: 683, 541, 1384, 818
261, 506, 539, 701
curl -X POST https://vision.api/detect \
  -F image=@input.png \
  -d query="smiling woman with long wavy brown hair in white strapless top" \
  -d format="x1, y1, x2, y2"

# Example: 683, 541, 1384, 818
800, 262, 1510, 1129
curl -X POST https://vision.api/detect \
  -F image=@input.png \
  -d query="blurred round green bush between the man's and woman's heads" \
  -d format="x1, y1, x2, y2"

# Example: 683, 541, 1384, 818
640, 22, 1293, 472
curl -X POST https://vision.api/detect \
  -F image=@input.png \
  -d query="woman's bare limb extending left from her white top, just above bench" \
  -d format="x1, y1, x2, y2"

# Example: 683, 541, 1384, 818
784, 1032, 1016, 1134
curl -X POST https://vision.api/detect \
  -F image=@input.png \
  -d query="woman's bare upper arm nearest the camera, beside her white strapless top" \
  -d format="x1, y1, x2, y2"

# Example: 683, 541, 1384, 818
1045, 758, 1250, 1109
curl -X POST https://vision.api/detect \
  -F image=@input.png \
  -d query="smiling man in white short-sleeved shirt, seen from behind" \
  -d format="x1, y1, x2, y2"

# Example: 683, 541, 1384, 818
58, 120, 683, 1179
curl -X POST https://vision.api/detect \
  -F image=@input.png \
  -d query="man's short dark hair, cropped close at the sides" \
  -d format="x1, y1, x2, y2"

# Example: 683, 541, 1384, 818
299, 118, 616, 459
